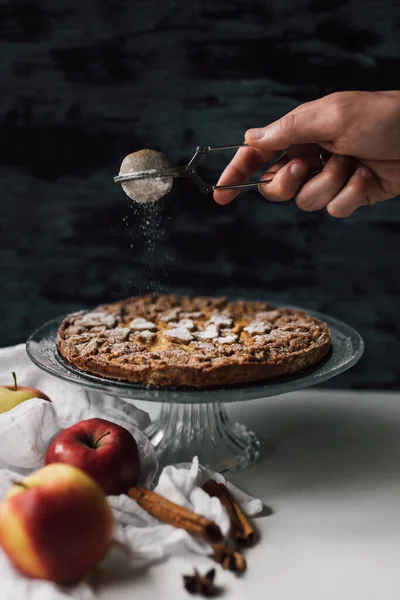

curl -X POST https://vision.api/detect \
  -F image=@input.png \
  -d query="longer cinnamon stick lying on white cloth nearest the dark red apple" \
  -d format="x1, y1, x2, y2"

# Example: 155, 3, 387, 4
128, 487, 223, 543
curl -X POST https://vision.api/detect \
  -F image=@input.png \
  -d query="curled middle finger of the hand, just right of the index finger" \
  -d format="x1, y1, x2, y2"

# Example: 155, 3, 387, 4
258, 159, 308, 202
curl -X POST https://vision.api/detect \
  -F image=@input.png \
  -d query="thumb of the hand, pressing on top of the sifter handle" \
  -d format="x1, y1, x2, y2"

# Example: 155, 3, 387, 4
245, 101, 338, 151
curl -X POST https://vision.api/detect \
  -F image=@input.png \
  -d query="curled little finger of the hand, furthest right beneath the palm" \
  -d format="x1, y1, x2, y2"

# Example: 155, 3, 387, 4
326, 167, 372, 218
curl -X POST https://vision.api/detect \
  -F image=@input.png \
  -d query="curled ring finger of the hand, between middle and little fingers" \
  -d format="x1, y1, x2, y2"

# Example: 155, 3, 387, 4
296, 156, 350, 212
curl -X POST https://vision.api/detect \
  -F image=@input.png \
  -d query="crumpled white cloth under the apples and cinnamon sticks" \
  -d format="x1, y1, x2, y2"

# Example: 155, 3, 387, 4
0, 345, 262, 600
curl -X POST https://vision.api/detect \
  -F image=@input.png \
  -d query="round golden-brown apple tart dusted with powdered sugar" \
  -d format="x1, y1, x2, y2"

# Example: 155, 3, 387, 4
57, 294, 331, 388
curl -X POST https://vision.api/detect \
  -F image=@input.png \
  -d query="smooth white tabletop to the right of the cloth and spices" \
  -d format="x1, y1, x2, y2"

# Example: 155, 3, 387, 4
97, 389, 400, 600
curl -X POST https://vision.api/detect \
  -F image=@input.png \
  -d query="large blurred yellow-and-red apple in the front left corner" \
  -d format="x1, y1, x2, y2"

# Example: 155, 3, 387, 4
0, 464, 113, 582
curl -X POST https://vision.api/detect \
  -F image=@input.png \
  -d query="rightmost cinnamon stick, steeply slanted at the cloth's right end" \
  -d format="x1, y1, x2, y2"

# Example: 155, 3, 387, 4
203, 479, 257, 548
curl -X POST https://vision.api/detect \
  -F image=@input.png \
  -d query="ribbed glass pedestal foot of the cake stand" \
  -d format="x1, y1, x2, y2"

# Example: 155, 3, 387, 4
145, 402, 260, 473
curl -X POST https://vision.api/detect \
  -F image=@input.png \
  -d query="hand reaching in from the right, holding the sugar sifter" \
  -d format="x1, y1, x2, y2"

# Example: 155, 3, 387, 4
214, 91, 400, 217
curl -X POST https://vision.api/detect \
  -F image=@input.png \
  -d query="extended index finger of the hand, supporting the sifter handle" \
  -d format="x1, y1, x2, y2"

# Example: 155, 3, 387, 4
214, 147, 275, 204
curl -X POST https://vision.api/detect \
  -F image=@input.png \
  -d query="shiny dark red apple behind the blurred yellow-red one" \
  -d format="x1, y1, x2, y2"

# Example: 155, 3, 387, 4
45, 419, 140, 495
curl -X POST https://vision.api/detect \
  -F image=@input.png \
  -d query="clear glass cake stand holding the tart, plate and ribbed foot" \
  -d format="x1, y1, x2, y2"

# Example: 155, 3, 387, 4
26, 311, 364, 472
